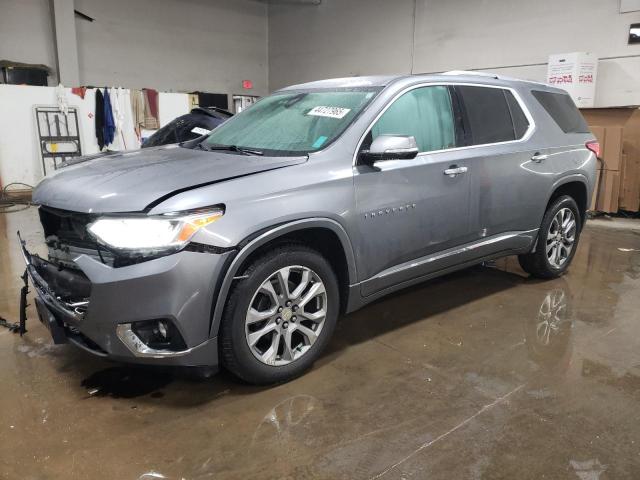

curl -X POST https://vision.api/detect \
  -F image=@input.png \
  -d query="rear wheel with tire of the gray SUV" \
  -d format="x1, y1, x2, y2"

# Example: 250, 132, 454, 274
518, 195, 582, 279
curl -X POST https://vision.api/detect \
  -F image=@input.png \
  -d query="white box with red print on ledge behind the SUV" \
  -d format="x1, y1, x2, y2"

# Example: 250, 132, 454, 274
547, 52, 598, 108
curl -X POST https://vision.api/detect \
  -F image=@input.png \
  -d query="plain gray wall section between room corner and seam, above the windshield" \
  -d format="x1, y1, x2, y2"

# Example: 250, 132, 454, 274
269, 0, 414, 90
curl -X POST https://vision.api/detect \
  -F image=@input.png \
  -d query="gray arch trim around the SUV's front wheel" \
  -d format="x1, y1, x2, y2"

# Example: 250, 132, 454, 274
209, 218, 357, 337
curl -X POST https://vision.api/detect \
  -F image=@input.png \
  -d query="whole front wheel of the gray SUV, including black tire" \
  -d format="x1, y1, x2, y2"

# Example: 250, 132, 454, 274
220, 245, 340, 385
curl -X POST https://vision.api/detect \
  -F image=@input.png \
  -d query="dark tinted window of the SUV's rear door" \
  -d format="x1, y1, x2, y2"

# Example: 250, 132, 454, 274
456, 86, 516, 145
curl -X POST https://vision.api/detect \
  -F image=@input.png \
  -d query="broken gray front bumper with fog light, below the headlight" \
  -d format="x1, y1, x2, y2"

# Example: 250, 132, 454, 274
20, 232, 231, 367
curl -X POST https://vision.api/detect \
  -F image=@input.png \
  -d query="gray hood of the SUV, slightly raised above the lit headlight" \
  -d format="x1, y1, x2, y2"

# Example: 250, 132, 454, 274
33, 145, 307, 213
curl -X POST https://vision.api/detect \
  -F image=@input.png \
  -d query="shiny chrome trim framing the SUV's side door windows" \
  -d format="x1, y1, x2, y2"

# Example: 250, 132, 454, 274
351, 82, 536, 167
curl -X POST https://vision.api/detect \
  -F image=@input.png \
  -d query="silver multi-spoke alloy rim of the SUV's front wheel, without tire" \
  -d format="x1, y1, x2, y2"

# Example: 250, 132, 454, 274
245, 265, 327, 366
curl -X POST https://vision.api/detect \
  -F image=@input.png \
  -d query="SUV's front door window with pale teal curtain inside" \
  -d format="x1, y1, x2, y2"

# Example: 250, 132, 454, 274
371, 86, 456, 152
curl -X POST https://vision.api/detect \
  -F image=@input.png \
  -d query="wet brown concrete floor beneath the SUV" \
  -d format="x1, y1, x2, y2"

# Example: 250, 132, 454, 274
0, 209, 640, 480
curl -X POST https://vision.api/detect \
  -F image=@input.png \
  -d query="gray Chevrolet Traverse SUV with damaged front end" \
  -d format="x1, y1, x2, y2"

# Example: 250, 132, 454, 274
23, 72, 599, 384
